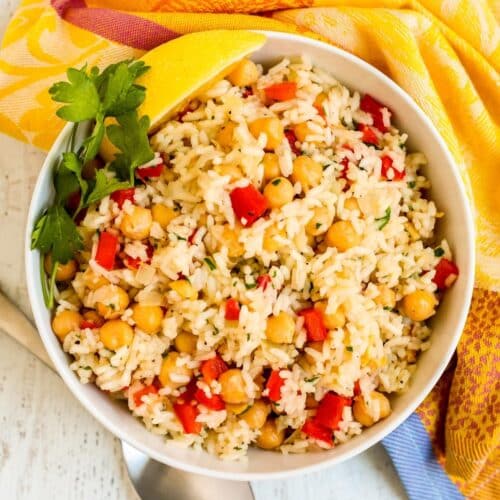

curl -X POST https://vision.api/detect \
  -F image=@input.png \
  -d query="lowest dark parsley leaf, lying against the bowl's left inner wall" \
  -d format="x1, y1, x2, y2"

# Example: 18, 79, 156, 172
31, 205, 83, 264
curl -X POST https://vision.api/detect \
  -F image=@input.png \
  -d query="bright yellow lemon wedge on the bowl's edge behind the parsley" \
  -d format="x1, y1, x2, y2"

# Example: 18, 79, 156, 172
100, 30, 266, 161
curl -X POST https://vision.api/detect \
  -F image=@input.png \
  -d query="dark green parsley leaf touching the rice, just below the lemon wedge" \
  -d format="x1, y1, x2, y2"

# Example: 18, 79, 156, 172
106, 111, 154, 183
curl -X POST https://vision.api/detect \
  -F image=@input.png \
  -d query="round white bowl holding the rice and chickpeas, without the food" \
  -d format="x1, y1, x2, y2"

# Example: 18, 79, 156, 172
25, 32, 474, 480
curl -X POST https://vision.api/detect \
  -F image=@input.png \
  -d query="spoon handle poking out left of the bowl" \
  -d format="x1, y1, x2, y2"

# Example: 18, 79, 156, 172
0, 291, 56, 371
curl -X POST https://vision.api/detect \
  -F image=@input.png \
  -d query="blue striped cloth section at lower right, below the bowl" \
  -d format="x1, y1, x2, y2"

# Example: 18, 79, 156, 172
383, 413, 464, 500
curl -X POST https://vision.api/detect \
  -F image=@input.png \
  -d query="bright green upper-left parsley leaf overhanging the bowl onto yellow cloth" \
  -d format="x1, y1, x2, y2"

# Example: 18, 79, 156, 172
49, 66, 100, 122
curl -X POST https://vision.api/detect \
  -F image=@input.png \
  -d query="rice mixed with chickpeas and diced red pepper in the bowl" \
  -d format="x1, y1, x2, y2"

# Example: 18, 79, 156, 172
48, 58, 458, 459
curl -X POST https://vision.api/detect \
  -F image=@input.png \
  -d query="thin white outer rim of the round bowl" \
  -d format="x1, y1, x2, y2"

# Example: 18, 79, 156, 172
24, 30, 475, 481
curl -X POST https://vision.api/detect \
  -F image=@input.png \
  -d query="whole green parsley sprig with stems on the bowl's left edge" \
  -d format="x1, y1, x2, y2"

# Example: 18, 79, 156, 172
31, 60, 154, 308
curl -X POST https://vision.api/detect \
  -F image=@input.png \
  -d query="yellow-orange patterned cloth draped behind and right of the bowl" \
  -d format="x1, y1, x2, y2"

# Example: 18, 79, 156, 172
0, 0, 500, 499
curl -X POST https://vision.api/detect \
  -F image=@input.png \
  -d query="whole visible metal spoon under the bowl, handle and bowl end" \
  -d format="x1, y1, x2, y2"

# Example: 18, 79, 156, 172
0, 291, 254, 500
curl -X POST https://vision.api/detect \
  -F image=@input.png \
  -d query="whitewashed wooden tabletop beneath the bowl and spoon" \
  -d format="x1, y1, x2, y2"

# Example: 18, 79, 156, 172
0, 0, 406, 500
